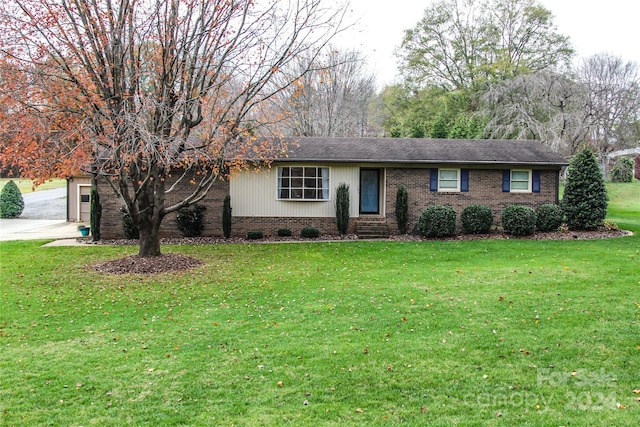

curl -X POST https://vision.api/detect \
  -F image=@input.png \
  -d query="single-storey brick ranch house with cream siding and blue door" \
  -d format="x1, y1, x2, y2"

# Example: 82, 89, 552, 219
84, 137, 568, 238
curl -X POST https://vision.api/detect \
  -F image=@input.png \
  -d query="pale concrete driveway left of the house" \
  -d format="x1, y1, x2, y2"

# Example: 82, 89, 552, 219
0, 188, 88, 241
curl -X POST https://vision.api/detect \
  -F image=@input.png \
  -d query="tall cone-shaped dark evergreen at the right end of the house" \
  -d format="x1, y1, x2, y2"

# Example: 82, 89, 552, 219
560, 148, 607, 230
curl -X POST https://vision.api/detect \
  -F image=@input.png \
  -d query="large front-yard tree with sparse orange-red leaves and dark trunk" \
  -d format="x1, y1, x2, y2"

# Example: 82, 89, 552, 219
0, 0, 346, 256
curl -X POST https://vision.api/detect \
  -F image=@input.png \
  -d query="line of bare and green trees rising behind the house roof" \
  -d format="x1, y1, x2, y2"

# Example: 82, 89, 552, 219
272, 0, 640, 162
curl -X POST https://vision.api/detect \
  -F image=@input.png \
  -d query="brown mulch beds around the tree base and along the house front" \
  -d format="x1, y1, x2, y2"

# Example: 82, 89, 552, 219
89, 228, 630, 275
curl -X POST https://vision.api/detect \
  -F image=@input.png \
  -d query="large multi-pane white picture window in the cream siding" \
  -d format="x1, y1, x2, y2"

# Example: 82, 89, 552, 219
278, 166, 329, 201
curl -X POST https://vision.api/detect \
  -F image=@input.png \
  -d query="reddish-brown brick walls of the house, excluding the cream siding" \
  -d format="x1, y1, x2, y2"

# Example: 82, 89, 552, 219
98, 168, 558, 239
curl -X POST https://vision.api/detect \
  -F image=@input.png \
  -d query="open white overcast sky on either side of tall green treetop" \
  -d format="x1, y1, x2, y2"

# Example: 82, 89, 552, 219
338, 0, 640, 86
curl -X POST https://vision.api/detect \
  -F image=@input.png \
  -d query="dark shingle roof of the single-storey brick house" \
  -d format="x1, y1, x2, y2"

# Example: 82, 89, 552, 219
278, 137, 568, 167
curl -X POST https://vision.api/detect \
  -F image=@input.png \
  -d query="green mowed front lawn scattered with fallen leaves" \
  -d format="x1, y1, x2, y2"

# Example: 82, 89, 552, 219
0, 183, 640, 426
